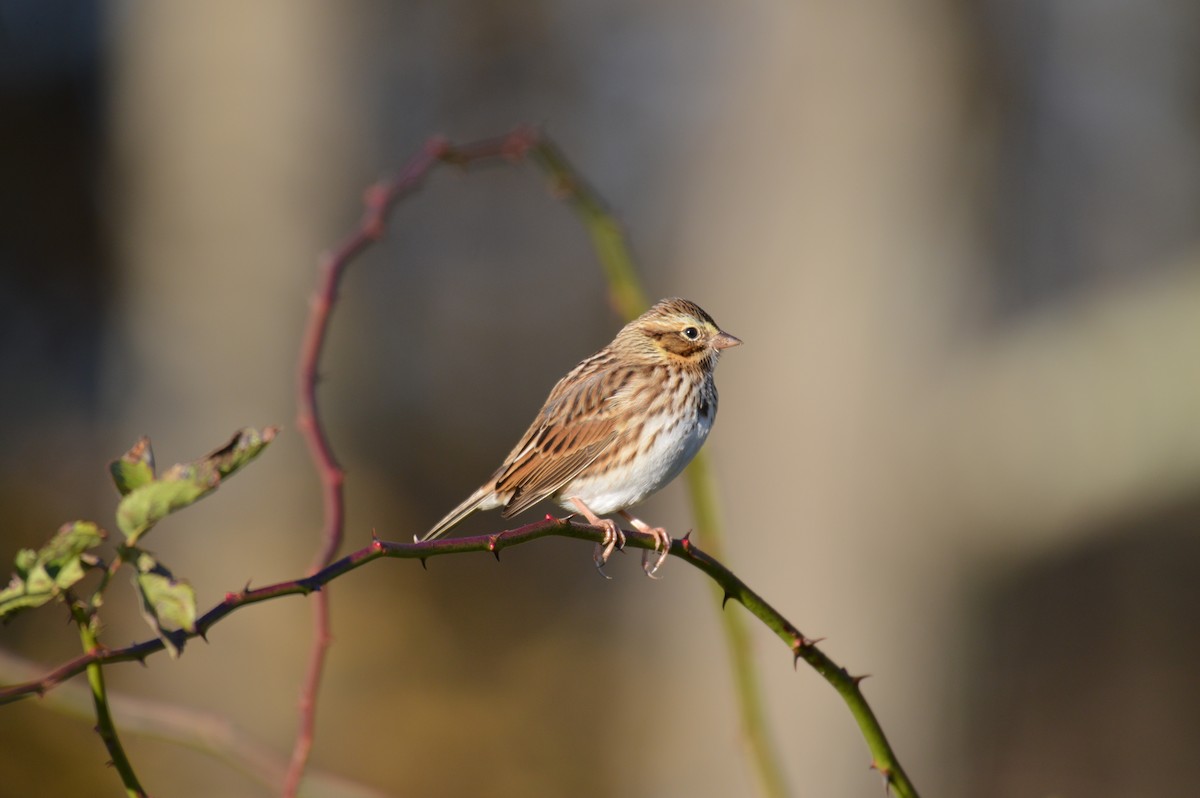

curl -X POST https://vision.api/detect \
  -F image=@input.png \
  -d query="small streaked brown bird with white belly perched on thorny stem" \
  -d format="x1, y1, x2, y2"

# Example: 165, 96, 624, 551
421, 299, 742, 577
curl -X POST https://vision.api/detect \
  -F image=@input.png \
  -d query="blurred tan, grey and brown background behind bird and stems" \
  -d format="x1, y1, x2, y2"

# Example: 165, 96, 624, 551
0, 0, 1200, 797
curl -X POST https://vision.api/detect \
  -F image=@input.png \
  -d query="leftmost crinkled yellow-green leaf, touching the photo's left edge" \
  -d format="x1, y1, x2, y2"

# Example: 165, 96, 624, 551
0, 521, 104, 618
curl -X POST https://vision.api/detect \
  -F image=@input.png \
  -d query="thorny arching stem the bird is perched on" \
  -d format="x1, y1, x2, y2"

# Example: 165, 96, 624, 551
0, 518, 917, 798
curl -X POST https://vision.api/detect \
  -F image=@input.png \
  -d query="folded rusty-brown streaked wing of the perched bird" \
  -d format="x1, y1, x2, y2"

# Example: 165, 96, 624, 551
496, 355, 634, 517
